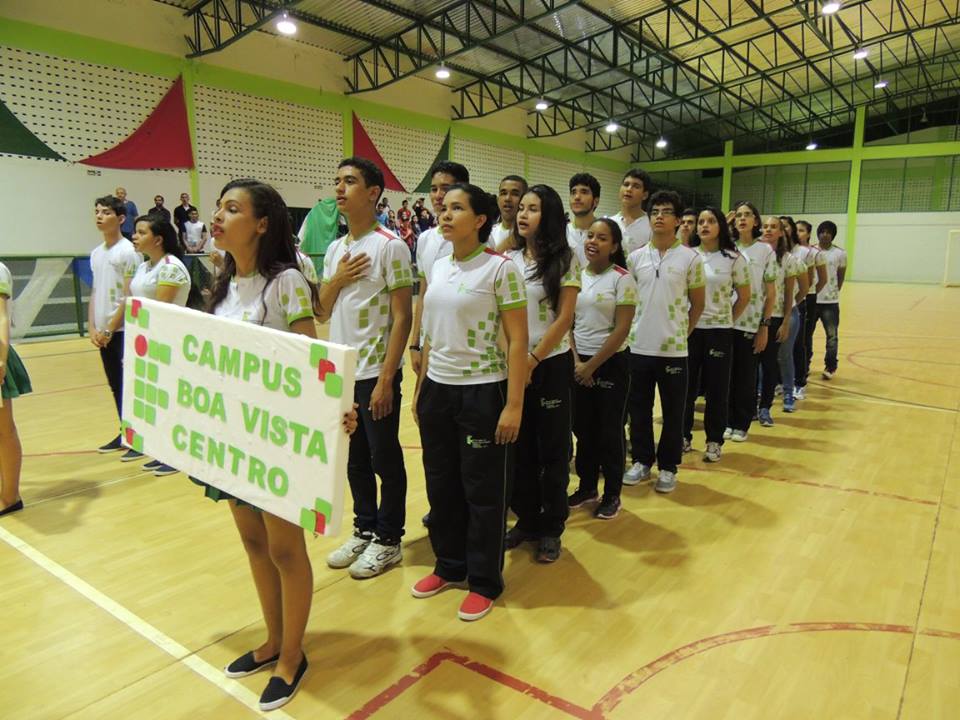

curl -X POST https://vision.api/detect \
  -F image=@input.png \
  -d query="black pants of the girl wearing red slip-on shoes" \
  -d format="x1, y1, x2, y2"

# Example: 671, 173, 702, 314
417, 377, 514, 599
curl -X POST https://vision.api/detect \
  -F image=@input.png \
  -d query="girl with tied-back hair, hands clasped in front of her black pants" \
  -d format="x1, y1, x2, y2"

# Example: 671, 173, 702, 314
568, 218, 637, 520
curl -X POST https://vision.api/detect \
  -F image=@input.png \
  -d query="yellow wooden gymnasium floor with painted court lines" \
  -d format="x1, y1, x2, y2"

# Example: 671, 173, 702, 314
0, 284, 960, 720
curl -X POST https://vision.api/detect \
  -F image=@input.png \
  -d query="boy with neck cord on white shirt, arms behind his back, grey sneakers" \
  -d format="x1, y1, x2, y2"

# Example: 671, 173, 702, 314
623, 190, 706, 493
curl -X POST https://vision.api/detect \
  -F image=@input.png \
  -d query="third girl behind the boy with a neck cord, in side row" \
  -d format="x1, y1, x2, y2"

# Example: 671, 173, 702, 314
757, 215, 800, 427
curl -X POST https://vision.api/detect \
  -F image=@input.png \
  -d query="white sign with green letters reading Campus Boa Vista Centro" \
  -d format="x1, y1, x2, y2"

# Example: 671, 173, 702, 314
123, 298, 357, 535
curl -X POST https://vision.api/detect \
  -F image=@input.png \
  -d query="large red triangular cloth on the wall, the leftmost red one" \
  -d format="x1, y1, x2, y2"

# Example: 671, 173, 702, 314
80, 77, 193, 170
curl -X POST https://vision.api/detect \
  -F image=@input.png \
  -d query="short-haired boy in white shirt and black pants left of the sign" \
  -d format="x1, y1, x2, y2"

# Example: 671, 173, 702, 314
87, 195, 143, 462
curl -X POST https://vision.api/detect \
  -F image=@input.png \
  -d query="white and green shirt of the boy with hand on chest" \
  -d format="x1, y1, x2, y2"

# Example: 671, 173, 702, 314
323, 225, 413, 380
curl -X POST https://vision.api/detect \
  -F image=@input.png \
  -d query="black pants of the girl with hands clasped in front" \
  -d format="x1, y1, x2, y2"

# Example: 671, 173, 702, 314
573, 350, 630, 498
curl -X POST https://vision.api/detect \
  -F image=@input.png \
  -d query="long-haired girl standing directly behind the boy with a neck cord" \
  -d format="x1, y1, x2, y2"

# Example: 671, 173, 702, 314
681, 207, 750, 462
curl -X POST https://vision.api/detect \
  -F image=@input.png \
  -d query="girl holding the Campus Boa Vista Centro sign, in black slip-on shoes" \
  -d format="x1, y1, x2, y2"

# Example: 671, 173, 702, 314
202, 179, 357, 711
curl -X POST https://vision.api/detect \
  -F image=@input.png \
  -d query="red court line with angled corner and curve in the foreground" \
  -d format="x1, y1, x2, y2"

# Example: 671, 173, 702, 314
347, 622, 960, 720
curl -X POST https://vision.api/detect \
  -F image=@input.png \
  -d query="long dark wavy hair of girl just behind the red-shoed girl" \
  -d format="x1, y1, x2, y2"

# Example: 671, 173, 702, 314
513, 185, 573, 312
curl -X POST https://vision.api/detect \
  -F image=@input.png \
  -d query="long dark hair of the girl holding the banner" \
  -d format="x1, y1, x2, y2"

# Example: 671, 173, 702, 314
207, 178, 319, 324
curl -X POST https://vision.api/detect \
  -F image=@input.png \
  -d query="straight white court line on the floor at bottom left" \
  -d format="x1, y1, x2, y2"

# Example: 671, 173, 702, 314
0, 527, 293, 720
